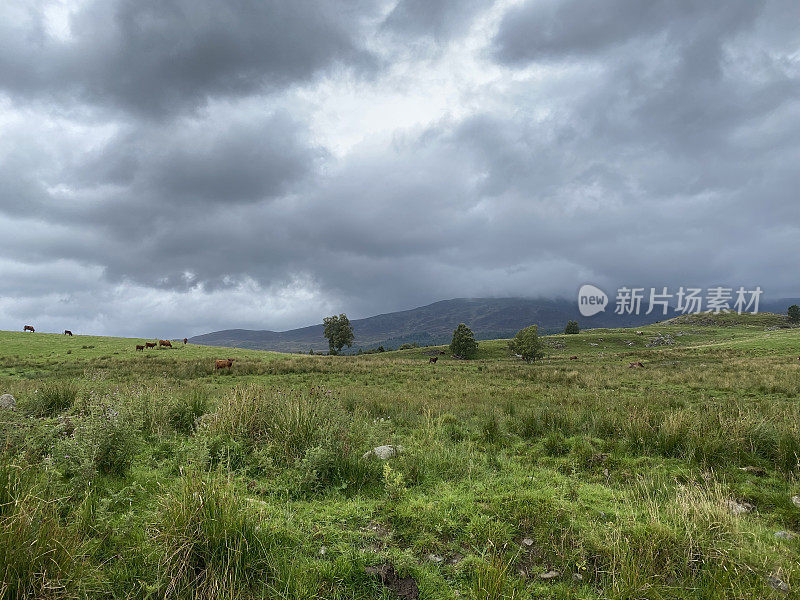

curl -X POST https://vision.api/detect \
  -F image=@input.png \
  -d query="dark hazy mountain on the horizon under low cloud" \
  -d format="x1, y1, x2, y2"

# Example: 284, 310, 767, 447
191, 298, 666, 352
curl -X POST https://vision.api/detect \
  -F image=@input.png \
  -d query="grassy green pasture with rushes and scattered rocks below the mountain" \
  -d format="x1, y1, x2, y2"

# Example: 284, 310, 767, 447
0, 315, 800, 599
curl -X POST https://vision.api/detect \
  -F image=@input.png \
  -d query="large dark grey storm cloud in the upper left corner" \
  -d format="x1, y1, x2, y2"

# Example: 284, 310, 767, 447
0, 0, 372, 115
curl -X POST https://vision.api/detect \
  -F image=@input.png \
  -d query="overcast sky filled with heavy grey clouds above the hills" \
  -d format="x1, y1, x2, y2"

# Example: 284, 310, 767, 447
0, 0, 800, 338
